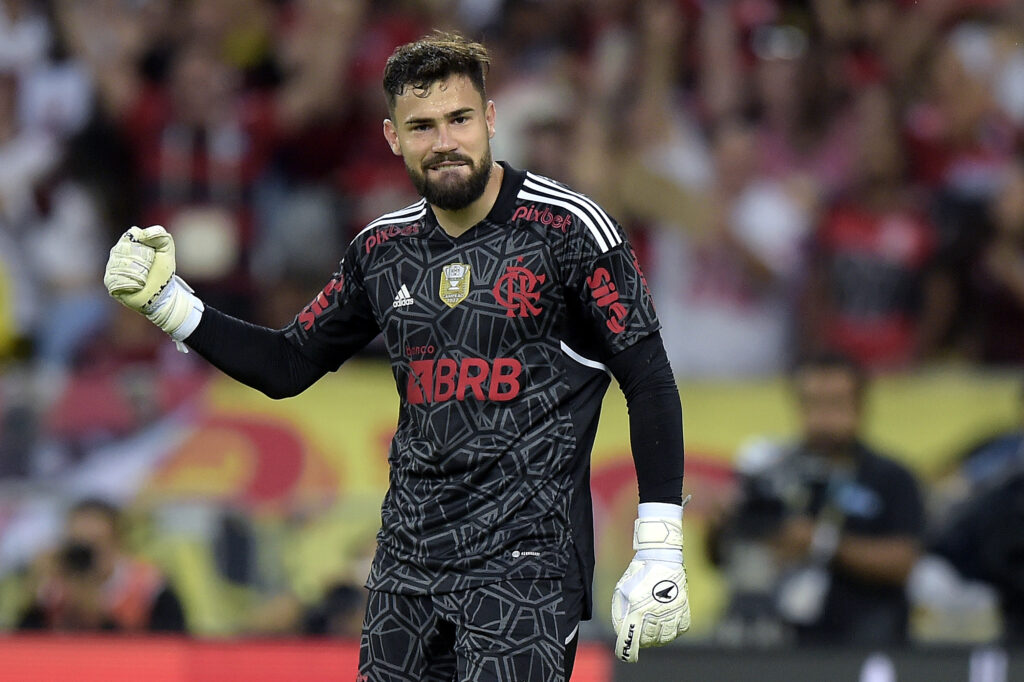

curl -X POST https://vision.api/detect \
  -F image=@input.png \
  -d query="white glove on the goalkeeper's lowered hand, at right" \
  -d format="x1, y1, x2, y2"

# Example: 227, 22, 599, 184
611, 498, 690, 663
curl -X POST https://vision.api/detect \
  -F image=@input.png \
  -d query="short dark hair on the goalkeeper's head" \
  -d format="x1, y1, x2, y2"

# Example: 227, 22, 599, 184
384, 31, 490, 115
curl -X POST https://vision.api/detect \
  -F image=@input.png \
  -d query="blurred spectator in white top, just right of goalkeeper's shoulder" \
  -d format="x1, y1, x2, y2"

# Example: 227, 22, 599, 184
650, 121, 809, 377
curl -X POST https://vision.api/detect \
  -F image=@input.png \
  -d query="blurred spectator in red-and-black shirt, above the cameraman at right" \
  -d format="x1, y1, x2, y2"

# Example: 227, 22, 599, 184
802, 88, 952, 369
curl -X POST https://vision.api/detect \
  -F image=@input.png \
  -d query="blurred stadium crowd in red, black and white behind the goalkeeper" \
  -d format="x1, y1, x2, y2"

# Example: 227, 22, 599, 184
0, 0, 1024, 647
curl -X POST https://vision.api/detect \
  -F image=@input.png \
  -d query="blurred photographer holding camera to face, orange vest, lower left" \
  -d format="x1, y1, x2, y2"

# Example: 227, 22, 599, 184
18, 493, 185, 632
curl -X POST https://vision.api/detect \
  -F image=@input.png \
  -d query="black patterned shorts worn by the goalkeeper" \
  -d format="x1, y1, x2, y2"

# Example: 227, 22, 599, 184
356, 570, 584, 682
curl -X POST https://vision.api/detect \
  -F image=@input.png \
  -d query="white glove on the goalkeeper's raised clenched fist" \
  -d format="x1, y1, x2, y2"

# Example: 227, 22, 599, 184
103, 225, 205, 352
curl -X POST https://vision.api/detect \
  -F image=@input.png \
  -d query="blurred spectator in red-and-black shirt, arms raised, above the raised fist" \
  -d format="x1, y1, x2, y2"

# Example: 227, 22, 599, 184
59, 0, 366, 314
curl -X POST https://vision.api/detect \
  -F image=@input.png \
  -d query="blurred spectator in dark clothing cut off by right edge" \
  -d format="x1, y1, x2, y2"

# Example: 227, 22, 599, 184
968, 162, 1024, 366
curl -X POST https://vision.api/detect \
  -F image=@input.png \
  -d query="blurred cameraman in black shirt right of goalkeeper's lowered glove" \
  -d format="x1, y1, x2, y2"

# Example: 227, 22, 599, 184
711, 354, 924, 644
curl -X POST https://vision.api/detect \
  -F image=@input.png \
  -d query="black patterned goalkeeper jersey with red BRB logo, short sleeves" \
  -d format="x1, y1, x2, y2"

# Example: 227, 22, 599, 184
287, 164, 658, 594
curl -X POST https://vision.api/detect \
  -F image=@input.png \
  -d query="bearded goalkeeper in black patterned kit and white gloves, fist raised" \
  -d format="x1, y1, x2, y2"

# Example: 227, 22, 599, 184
105, 33, 690, 682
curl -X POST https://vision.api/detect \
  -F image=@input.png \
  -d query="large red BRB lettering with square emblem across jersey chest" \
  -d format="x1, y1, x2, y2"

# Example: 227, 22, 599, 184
406, 357, 522, 404
